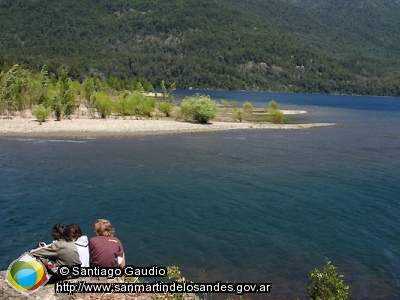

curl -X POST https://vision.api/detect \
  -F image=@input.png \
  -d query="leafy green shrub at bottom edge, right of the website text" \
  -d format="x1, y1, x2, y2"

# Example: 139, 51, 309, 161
307, 259, 349, 300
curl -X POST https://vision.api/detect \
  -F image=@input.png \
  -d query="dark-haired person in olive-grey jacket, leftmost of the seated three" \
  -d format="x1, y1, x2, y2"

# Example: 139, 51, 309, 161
30, 223, 81, 275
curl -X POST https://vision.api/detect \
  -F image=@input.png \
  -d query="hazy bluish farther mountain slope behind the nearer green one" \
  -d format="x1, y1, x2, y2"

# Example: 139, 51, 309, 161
227, 0, 400, 59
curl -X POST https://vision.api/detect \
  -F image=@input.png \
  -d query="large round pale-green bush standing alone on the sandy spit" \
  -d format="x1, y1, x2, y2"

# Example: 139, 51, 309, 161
179, 94, 217, 123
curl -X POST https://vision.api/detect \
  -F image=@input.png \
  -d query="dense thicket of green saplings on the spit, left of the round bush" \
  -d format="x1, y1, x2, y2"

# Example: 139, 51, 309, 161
0, 64, 175, 122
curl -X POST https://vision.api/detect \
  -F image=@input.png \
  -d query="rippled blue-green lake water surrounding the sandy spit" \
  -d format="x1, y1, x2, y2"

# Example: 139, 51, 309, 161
0, 91, 400, 299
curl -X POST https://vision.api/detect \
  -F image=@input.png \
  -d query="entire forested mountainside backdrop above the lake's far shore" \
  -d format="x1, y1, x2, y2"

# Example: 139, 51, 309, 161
0, 0, 400, 96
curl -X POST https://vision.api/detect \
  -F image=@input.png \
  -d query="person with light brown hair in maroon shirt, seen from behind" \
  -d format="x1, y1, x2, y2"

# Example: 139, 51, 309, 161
89, 219, 125, 268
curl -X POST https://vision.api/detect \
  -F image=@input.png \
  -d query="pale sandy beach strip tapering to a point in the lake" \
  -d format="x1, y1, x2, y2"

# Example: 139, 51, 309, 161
0, 117, 335, 138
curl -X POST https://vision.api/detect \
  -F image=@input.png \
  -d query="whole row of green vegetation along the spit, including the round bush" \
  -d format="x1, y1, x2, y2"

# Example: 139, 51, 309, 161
0, 64, 290, 124
